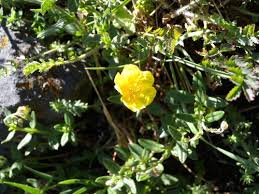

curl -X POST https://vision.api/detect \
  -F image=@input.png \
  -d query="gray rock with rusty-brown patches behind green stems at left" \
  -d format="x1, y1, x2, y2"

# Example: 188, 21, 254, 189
0, 25, 91, 129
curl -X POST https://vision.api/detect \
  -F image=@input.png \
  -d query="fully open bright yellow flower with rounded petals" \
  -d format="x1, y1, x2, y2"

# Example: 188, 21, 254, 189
114, 65, 156, 112
